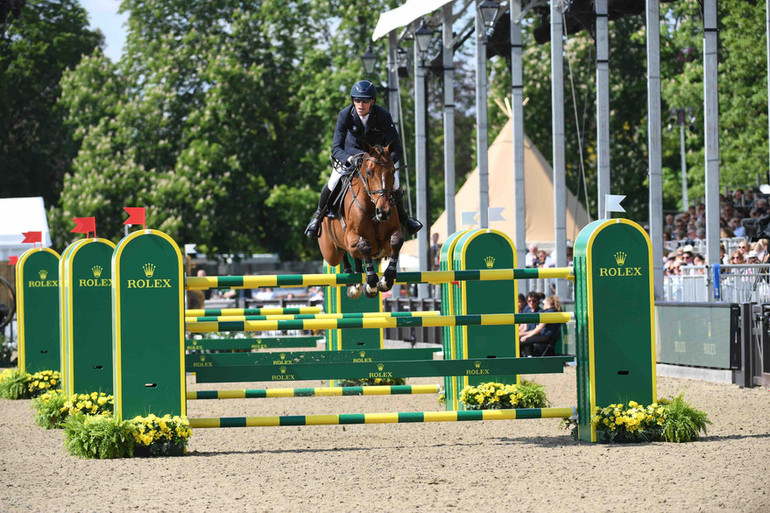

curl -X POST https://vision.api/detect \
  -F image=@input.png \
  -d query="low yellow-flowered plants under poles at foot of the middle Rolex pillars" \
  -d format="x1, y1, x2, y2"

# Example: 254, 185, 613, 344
460, 380, 550, 410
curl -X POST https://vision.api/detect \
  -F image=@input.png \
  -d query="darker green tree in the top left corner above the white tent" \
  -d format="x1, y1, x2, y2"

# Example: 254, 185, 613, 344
0, 0, 102, 205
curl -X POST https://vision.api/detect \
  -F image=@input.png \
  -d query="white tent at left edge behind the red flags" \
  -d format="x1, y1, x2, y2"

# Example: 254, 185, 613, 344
0, 197, 51, 261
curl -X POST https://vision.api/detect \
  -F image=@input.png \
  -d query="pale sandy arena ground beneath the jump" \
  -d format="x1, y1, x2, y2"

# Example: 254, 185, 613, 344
0, 368, 770, 512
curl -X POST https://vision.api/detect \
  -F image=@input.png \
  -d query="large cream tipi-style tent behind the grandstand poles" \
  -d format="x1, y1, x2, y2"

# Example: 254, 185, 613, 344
401, 120, 589, 255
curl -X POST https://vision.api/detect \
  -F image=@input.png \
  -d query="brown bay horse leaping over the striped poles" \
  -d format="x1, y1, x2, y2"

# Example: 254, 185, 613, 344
318, 144, 404, 299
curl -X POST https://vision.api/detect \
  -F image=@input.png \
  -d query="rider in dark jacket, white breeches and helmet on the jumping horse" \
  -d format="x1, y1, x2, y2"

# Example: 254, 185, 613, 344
305, 80, 422, 238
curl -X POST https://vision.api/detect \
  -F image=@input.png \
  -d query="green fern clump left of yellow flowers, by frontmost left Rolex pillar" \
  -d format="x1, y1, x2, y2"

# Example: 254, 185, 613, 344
64, 413, 134, 459
